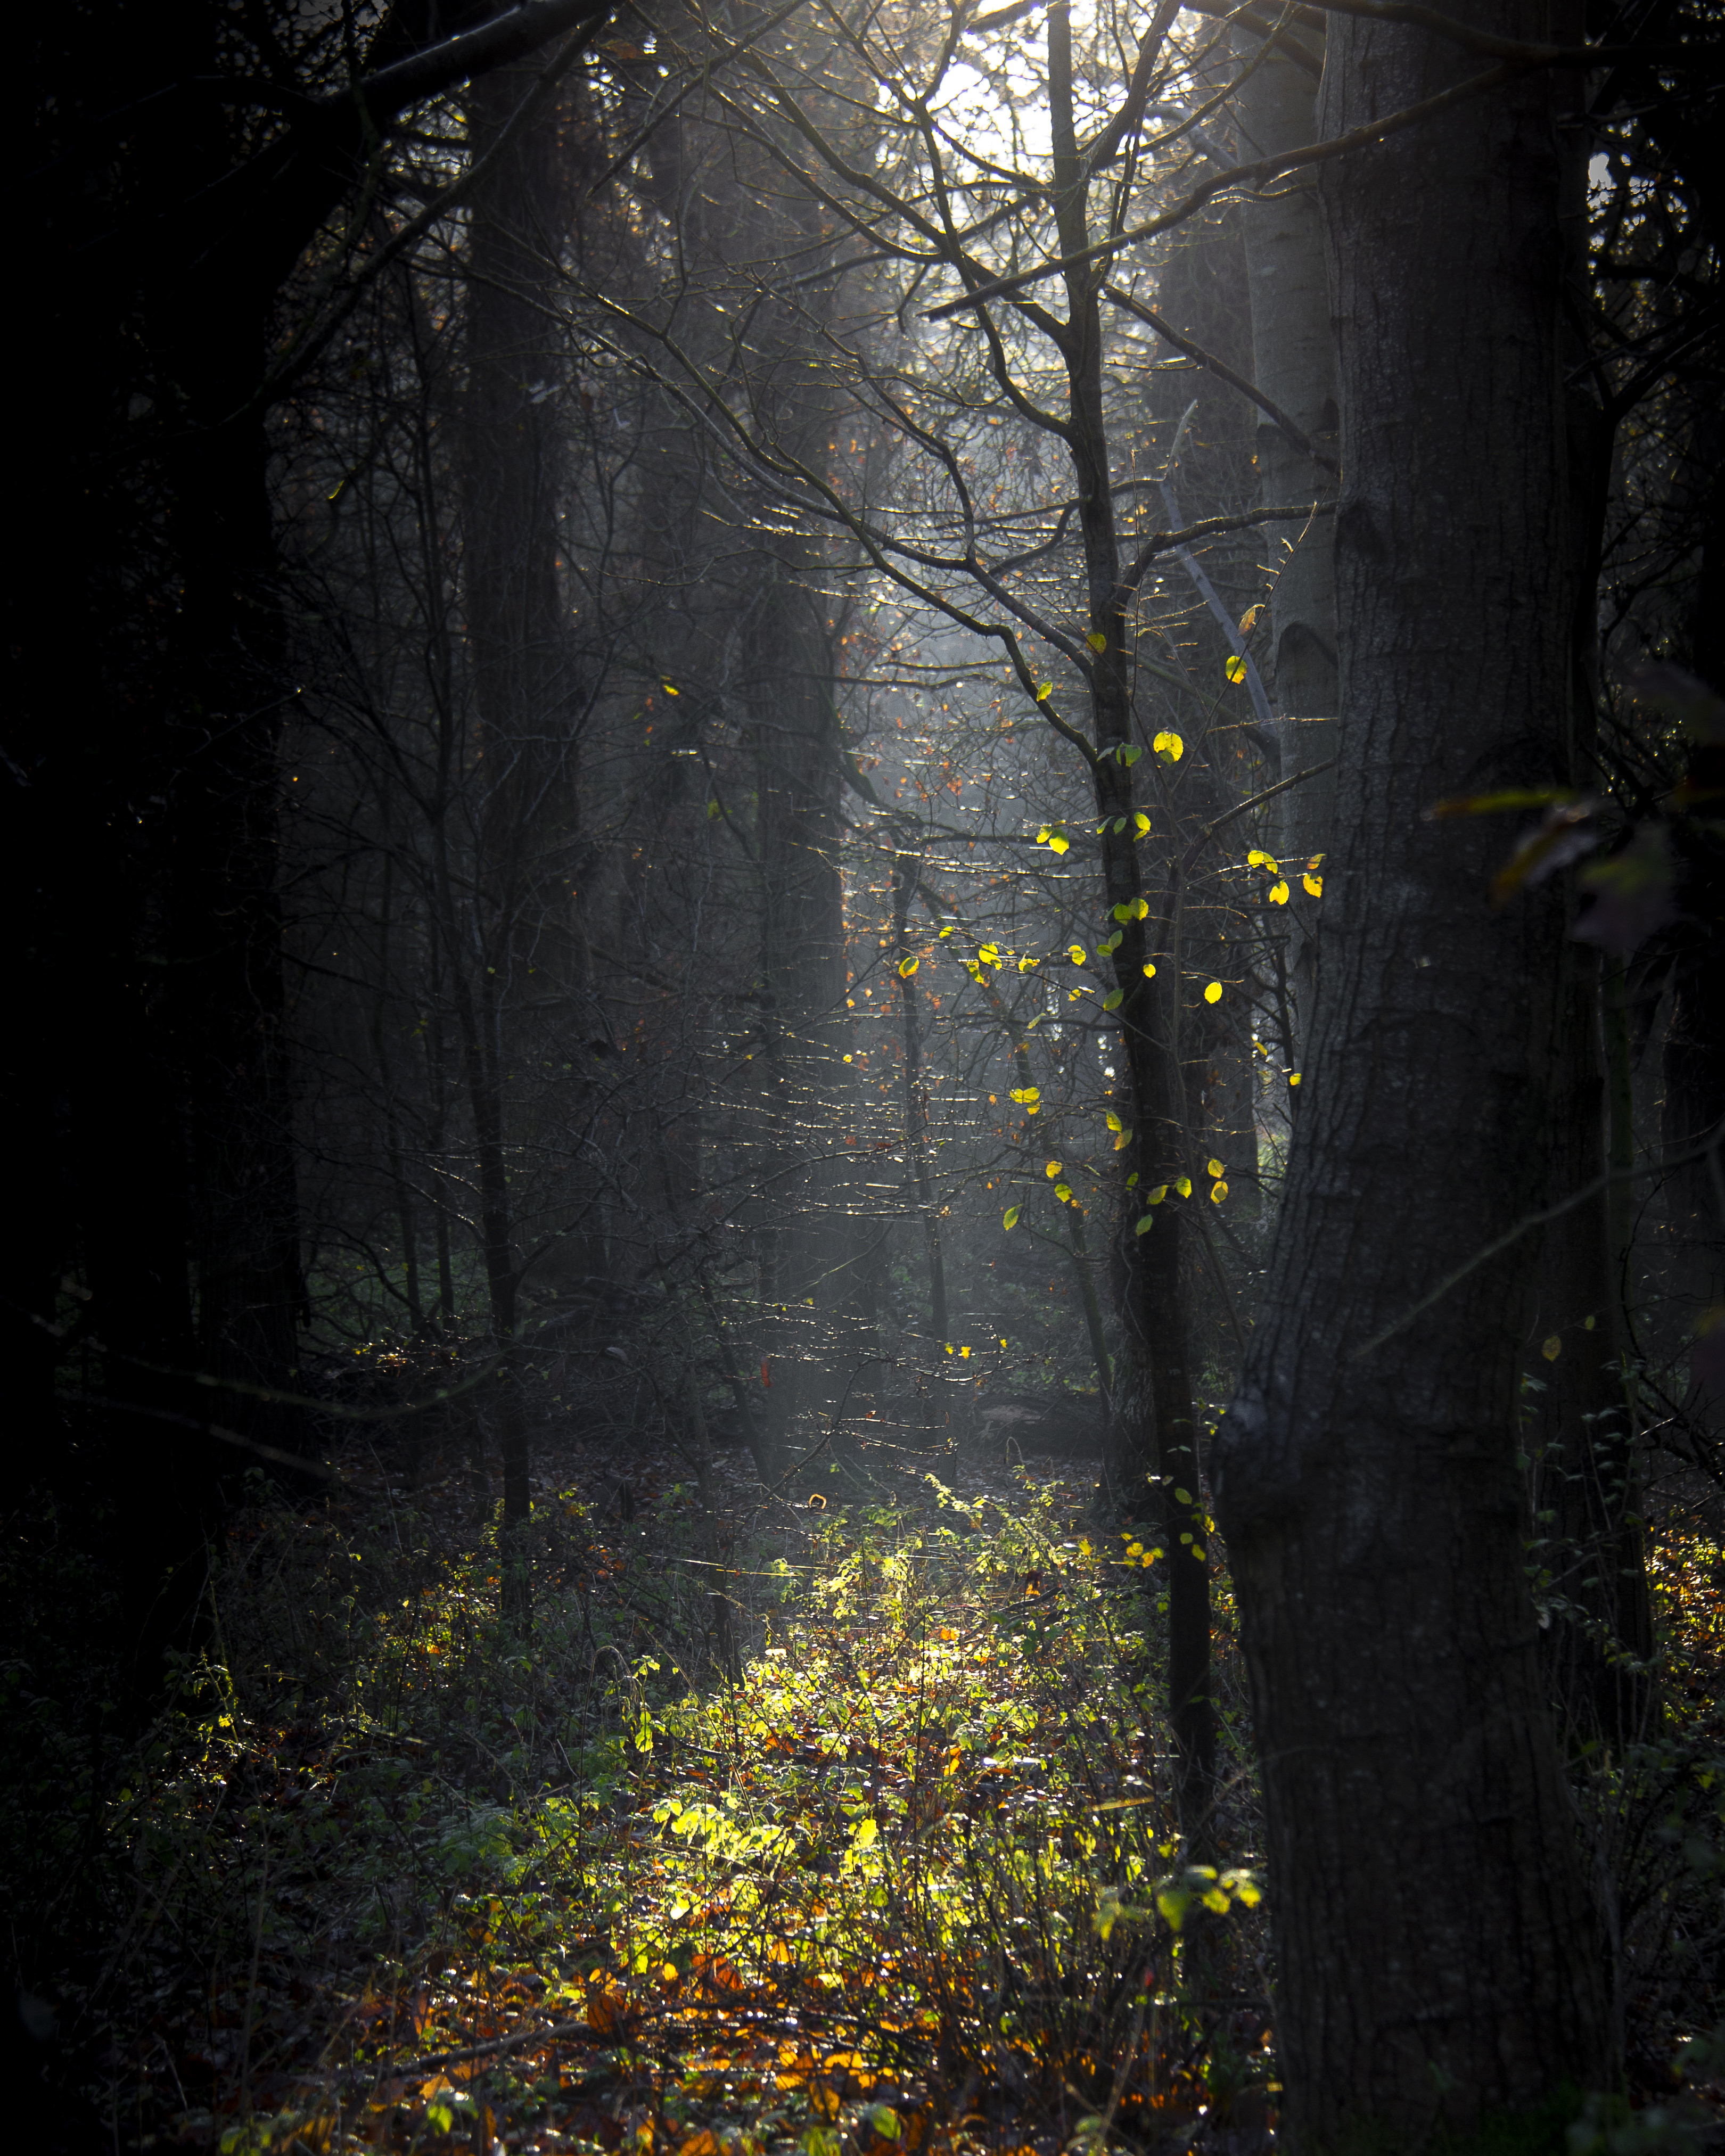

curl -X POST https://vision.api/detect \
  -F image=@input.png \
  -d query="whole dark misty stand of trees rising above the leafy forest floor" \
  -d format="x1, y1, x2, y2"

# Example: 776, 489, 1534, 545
4, 0, 1725, 2150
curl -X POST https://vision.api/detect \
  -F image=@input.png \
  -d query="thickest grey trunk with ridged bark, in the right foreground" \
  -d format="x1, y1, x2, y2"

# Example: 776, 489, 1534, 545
1214, 12, 1611, 2156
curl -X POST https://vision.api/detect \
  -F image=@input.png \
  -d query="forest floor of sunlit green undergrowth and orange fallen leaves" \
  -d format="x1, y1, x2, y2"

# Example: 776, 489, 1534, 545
4, 1405, 1725, 2156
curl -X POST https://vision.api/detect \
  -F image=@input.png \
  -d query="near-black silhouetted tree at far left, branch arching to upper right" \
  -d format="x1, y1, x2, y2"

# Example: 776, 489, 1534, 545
4, 0, 621, 1694
